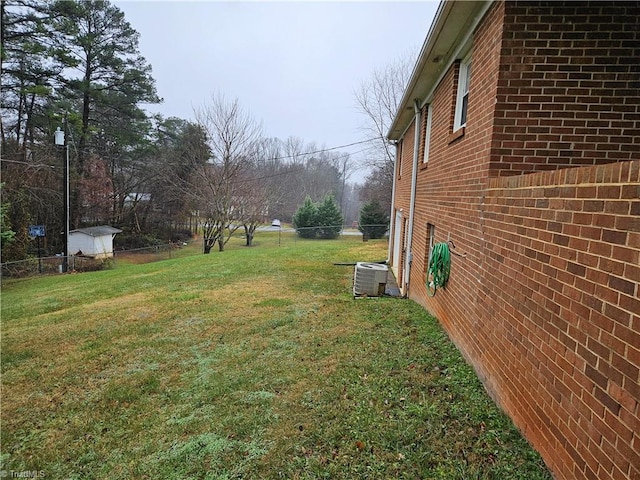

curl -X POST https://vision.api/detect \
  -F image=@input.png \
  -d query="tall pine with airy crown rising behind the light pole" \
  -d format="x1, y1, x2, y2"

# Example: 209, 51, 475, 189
52, 0, 160, 226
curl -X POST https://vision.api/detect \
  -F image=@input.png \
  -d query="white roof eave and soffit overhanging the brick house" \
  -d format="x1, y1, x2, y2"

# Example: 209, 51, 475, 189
387, 0, 492, 140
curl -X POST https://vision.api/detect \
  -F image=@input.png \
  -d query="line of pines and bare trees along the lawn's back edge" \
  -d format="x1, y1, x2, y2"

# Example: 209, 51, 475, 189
0, 0, 404, 261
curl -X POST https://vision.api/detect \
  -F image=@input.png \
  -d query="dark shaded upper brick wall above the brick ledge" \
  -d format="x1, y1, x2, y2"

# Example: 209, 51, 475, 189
492, 1, 640, 175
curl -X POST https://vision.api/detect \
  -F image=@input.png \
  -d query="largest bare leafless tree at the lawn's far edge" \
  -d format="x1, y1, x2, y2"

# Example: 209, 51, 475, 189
191, 95, 262, 253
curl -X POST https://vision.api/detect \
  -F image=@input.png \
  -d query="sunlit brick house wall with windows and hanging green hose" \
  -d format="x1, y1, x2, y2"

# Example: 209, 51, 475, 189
409, 2, 504, 364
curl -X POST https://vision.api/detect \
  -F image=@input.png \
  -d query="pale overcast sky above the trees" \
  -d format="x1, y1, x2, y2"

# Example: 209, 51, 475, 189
114, 0, 438, 178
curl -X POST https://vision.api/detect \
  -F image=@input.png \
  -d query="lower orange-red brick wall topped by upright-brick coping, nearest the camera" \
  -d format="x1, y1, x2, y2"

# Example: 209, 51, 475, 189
477, 161, 640, 480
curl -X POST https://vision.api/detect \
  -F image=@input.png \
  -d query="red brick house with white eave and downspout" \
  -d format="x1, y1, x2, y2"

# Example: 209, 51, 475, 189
388, 1, 640, 480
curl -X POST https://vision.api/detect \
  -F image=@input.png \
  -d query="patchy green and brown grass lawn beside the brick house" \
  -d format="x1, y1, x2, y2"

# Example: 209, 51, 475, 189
0, 233, 551, 480
